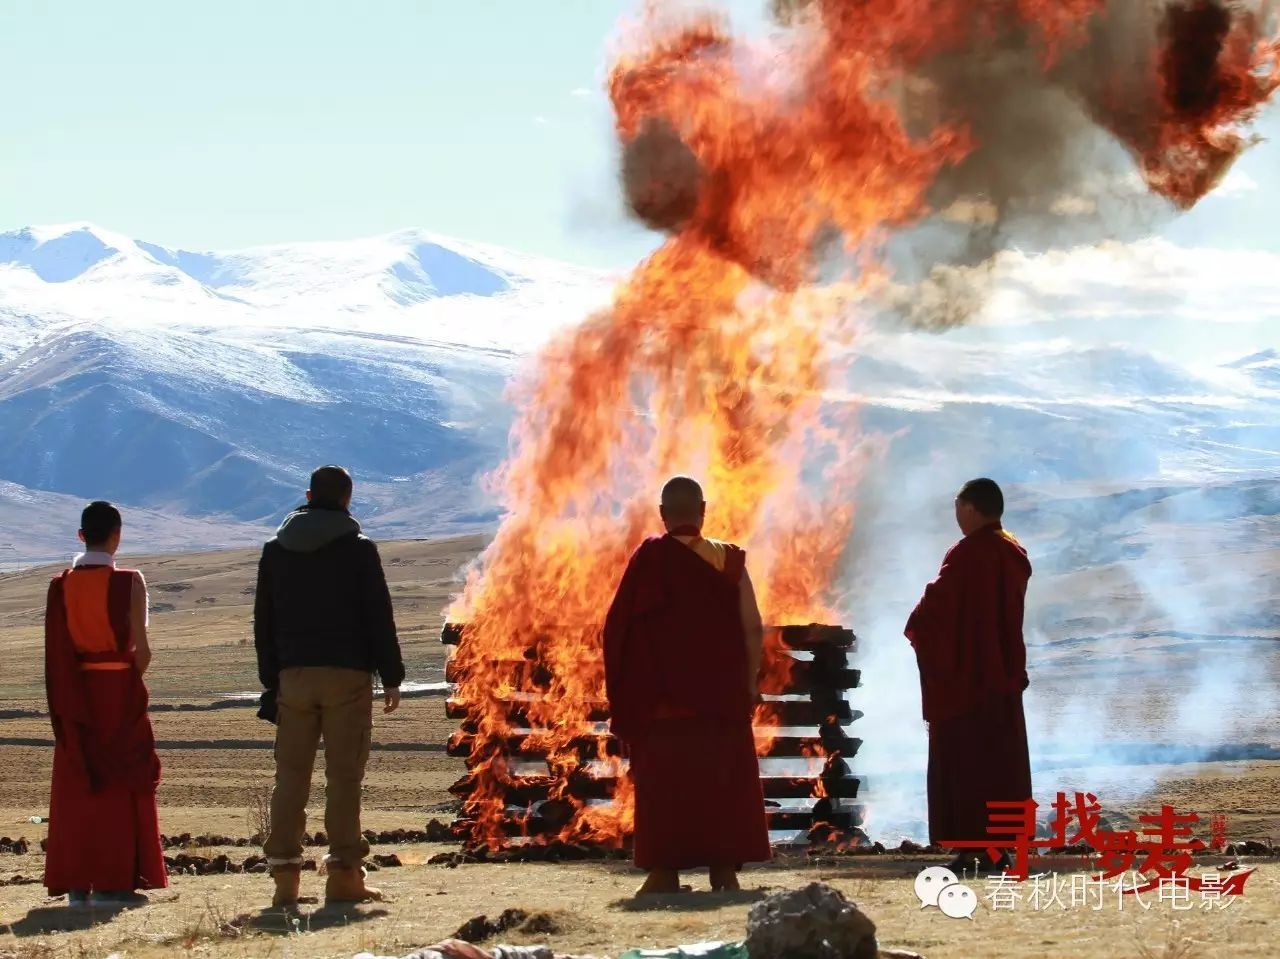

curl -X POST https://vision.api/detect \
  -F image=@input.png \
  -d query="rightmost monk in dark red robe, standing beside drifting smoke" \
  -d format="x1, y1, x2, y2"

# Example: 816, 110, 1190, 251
906, 479, 1032, 871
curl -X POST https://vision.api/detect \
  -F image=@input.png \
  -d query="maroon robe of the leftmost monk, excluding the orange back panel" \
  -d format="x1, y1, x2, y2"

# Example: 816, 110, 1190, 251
45, 567, 169, 895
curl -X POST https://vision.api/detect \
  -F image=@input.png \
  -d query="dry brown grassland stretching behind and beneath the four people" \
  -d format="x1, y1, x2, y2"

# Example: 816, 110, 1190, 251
0, 538, 1280, 959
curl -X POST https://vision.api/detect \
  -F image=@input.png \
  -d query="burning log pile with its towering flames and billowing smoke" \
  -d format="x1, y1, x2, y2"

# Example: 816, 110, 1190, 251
427, 0, 1280, 850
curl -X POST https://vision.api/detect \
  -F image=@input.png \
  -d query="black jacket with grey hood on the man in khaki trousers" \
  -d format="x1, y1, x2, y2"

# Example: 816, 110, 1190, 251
253, 506, 404, 690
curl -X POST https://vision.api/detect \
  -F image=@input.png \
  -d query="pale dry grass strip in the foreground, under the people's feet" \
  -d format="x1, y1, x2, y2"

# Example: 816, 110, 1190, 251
0, 846, 1280, 959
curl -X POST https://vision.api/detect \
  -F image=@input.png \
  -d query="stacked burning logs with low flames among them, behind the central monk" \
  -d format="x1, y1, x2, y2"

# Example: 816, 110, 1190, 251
442, 624, 865, 848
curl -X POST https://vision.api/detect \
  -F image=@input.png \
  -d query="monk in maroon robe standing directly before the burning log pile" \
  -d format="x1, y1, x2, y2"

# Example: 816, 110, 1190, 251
604, 476, 771, 895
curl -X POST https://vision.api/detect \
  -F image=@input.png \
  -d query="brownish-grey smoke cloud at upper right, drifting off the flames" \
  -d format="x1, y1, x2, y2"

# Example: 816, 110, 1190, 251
798, 0, 1274, 328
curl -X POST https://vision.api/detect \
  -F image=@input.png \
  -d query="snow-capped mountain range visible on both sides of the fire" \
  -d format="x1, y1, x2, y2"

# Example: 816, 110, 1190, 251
0, 224, 1280, 562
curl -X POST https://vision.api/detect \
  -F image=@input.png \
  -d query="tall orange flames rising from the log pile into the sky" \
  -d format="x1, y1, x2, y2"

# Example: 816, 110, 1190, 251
449, 0, 1277, 846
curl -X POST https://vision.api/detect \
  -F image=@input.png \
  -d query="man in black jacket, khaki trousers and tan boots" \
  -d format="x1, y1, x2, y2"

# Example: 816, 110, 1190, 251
253, 466, 404, 907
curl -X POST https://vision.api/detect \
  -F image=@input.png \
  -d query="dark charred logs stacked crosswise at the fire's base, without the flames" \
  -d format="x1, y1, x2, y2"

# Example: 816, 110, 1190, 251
440, 624, 865, 845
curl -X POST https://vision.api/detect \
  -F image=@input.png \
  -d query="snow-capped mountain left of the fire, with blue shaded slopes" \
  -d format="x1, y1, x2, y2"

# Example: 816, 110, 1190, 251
0, 224, 608, 561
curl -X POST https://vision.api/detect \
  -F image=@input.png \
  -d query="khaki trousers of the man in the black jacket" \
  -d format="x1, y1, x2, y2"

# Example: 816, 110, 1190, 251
262, 666, 374, 866
